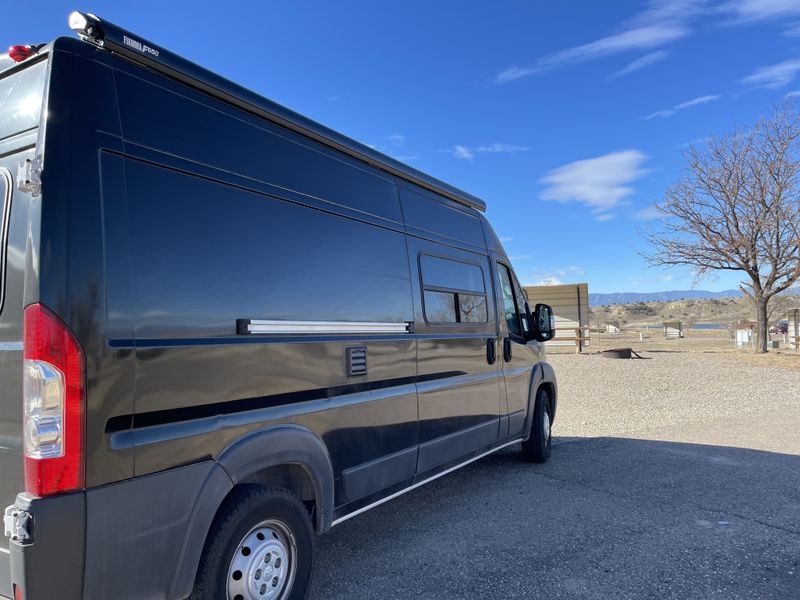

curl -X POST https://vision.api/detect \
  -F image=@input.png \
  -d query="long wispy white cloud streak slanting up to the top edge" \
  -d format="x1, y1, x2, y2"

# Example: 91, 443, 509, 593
494, 0, 703, 84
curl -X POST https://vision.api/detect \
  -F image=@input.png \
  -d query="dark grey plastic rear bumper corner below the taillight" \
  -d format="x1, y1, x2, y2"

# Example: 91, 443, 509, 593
9, 461, 232, 600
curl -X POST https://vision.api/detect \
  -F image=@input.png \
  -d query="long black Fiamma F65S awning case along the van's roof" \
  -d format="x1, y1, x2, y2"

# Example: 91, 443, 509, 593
69, 11, 486, 212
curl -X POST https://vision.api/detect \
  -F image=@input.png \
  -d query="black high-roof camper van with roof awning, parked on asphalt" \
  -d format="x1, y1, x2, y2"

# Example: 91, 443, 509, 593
0, 13, 556, 600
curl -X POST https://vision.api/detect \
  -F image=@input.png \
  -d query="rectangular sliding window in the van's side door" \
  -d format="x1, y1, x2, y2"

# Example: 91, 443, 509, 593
419, 254, 488, 323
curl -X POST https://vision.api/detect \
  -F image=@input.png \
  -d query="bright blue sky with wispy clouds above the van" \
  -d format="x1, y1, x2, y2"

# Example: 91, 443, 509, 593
0, 0, 800, 292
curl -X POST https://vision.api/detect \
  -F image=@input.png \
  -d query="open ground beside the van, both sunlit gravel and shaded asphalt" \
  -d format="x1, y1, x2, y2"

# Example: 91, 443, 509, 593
311, 353, 800, 600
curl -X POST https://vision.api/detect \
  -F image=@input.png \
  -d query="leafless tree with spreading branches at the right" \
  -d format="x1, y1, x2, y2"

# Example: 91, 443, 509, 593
644, 103, 800, 352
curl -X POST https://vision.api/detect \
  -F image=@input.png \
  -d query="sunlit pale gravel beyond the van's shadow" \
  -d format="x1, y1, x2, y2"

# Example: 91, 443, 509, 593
548, 351, 800, 451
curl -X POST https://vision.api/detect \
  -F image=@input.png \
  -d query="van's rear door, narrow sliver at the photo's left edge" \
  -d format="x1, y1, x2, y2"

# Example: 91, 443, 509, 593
0, 57, 47, 596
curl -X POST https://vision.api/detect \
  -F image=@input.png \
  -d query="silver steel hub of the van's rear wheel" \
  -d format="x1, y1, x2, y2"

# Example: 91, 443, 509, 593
228, 520, 297, 600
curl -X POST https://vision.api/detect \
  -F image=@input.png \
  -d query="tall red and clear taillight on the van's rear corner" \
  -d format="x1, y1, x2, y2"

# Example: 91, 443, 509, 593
23, 304, 84, 496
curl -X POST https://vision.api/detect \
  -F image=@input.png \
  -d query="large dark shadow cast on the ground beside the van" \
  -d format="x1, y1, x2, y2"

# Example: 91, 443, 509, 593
309, 438, 800, 600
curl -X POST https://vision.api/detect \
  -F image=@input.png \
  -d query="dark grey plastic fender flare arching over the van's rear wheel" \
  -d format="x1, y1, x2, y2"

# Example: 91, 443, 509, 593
217, 425, 334, 533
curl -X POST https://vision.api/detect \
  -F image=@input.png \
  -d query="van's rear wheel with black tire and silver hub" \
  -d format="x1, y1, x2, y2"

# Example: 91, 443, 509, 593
190, 486, 314, 600
